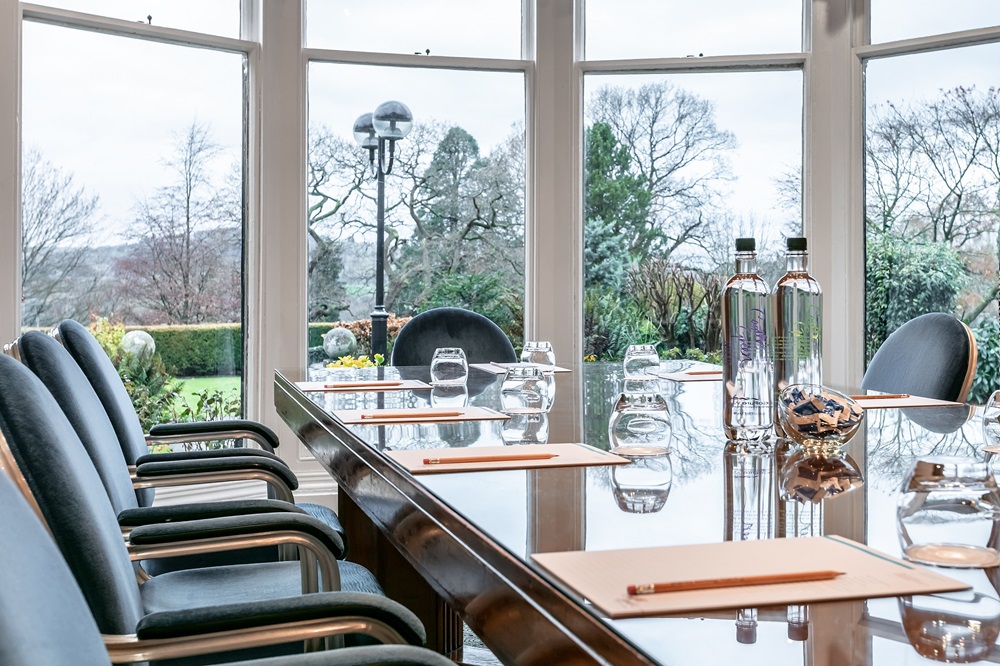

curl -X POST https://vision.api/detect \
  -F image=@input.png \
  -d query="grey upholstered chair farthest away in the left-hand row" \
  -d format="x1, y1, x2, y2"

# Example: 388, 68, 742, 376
50, 319, 344, 539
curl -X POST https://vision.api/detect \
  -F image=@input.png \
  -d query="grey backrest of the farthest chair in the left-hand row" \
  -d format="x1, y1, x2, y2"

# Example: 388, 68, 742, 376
56, 319, 154, 506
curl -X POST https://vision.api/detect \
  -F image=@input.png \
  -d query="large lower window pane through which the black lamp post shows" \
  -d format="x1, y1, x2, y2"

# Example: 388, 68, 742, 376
306, 63, 525, 360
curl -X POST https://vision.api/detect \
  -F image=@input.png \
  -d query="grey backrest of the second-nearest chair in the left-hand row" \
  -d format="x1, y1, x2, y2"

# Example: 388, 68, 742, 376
0, 356, 142, 634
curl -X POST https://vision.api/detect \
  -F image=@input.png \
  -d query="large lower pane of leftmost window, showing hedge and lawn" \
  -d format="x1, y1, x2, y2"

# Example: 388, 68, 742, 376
22, 23, 245, 426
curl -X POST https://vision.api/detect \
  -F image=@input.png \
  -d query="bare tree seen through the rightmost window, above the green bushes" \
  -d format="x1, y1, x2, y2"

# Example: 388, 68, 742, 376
865, 87, 1000, 321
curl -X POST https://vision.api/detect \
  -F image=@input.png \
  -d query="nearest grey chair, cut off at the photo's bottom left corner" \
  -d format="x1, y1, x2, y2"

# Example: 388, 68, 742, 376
0, 464, 452, 666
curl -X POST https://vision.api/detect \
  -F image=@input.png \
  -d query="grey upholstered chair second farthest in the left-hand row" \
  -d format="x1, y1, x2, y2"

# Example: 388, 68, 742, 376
17, 331, 346, 575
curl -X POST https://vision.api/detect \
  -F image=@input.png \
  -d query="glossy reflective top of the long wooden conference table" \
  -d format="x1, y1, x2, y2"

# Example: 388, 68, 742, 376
278, 363, 1000, 665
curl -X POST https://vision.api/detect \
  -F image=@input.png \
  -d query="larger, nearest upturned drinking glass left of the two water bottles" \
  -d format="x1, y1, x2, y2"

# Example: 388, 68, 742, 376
608, 393, 671, 458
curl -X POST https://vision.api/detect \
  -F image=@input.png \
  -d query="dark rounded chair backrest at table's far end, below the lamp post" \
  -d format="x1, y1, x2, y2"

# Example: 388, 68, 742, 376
390, 308, 517, 365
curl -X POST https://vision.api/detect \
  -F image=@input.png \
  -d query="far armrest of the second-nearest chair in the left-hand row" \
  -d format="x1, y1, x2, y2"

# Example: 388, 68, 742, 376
129, 512, 345, 565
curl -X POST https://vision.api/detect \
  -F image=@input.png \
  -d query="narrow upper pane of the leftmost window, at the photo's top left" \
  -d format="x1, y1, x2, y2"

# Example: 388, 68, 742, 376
32, 0, 240, 38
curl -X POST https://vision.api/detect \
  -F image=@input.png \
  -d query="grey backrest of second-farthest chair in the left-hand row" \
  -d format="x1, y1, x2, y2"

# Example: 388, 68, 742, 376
18, 331, 139, 513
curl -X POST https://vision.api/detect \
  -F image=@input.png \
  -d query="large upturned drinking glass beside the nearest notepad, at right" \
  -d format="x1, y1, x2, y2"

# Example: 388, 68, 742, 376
896, 456, 1000, 569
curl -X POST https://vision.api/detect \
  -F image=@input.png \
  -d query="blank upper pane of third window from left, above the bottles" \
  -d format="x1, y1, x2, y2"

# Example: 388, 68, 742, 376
586, 0, 802, 60
